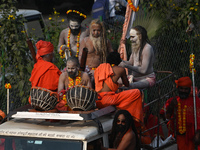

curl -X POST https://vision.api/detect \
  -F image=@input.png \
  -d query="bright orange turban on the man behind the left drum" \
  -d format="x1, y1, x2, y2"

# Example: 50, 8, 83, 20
36, 40, 54, 60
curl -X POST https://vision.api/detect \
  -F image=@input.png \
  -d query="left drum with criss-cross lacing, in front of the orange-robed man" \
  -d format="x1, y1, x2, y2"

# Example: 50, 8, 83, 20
30, 87, 59, 111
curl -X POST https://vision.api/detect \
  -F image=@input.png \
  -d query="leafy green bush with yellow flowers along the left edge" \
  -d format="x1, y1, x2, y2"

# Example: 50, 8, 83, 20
0, 0, 33, 111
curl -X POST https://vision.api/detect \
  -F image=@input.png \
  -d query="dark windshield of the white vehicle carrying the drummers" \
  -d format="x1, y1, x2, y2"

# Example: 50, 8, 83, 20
0, 137, 83, 150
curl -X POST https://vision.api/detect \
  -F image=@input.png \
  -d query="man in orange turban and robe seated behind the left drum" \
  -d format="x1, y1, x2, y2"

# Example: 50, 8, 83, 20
29, 40, 61, 92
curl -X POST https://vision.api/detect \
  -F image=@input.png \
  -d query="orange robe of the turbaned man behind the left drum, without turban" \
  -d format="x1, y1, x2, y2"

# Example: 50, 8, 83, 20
29, 59, 61, 91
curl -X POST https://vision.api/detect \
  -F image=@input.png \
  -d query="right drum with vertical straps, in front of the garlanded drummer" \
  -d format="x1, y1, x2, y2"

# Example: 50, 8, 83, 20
66, 85, 97, 111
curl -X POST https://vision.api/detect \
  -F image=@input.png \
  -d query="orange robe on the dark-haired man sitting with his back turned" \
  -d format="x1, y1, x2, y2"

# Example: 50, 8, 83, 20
94, 63, 143, 123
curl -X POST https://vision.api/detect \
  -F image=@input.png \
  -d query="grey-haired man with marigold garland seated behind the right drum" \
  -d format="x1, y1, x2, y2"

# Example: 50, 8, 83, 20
56, 57, 92, 111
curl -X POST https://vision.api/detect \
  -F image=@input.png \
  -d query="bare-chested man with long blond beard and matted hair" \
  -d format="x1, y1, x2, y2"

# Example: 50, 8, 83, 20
79, 19, 113, 75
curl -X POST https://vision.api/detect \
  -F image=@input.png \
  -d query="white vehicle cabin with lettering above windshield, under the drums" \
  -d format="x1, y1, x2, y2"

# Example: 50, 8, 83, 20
0, 107, 115, 150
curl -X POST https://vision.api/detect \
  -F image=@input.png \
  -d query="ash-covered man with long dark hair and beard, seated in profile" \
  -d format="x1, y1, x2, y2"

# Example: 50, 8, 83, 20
120, 26, 156, 89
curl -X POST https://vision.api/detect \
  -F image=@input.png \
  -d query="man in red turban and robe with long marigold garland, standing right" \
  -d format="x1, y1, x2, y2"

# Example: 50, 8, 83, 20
160, 77, 200, 150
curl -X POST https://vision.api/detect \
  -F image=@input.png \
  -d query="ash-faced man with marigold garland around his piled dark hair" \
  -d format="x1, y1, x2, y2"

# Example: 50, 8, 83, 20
58, 9, 89, 59
